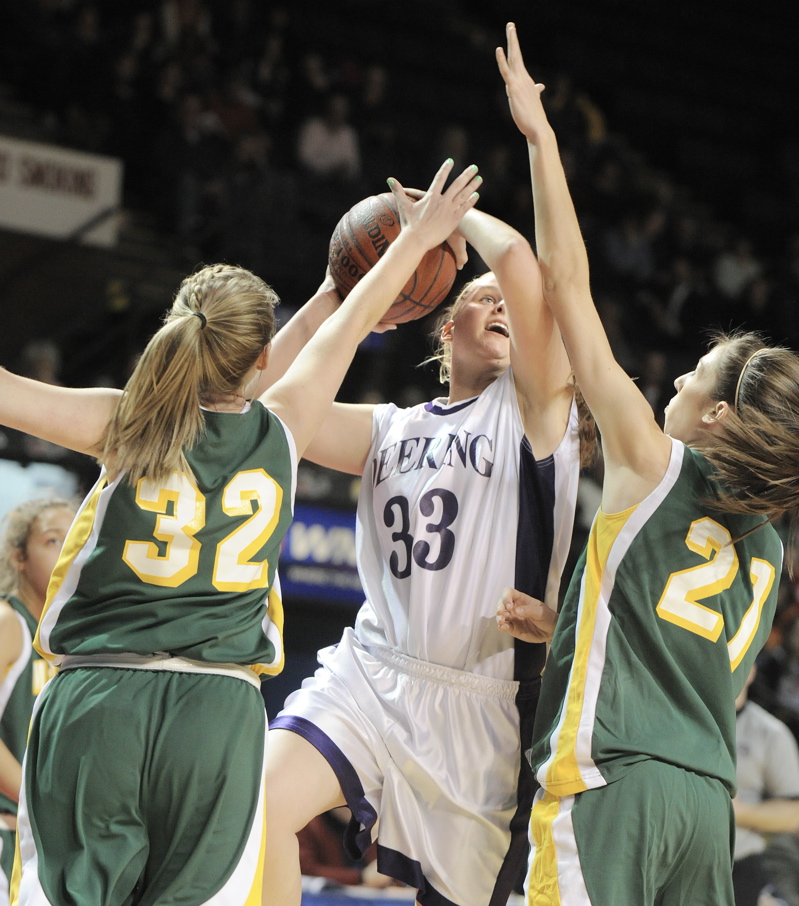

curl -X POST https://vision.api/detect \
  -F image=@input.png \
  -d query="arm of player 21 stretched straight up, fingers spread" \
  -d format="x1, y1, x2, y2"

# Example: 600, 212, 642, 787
497, 23, 671, 512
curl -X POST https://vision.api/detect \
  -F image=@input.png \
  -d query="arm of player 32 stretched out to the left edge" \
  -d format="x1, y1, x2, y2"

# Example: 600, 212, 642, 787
0, 368, 122, 456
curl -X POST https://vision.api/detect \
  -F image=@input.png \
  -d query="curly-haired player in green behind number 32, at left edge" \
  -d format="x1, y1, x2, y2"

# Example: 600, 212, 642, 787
0, 497, 75, 906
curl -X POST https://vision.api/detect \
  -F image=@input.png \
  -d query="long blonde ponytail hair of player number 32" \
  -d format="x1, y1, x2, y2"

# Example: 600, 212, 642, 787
100, 264, 278, 484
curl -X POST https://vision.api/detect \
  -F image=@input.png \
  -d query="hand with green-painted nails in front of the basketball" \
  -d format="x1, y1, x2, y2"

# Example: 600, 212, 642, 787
388, 158, 482, 249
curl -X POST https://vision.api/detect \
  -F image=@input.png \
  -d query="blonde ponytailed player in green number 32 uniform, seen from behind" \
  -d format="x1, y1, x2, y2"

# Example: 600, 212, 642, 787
0, 161, 479, 906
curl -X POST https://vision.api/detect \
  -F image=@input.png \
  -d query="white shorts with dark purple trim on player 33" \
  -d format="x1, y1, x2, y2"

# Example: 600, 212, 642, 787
270, 629, 539, 906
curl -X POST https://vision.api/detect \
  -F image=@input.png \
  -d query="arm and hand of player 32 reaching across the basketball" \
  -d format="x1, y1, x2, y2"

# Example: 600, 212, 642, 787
261, 160, 477, 455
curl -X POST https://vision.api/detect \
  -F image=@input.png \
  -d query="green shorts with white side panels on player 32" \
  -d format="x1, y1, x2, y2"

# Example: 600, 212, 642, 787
12, 667, 266, 906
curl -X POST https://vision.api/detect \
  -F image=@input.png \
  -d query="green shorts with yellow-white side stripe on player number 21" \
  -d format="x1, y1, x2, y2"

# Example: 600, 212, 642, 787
525, 760, 735, 906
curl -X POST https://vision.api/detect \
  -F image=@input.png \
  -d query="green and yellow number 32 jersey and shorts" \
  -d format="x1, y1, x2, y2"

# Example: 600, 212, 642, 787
11, 403, 296, 906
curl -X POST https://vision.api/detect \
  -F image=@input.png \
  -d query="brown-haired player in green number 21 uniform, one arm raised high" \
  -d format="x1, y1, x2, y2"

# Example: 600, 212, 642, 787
497, 25, 799, 906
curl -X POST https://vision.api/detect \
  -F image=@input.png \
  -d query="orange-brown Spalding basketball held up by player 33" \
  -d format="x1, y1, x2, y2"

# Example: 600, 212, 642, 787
328, 192, 458, 324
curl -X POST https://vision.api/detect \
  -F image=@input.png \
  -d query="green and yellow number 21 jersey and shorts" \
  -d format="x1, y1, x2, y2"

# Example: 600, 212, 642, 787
529, 441, 782, 906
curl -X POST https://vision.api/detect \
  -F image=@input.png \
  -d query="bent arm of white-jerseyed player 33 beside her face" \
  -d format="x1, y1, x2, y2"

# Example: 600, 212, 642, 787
459, 210, 572, 459
